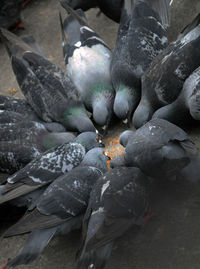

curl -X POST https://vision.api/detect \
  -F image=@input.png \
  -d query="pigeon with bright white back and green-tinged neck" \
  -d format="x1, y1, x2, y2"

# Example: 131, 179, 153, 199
61, 0, 114, 131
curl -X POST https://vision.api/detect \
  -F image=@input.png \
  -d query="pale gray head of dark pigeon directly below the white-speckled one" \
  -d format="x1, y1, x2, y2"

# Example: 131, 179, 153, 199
81, 148, 109, 173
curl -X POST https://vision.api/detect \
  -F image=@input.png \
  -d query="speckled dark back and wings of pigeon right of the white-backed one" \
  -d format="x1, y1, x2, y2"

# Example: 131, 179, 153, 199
111, 1, 168, 85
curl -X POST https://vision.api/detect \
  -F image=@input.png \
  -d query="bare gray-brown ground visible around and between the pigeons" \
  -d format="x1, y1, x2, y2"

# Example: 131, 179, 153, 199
0, 0, 200, 269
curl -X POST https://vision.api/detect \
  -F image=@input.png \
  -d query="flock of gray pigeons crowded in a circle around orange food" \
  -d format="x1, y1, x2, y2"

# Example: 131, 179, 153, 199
0, 0, 200, 269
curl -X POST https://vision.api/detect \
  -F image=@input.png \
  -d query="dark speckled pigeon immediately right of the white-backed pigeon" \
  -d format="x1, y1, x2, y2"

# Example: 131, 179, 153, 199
111, 0, 170, 127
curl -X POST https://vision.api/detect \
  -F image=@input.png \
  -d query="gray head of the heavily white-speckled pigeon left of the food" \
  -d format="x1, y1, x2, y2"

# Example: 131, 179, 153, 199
74, 132, 102, 151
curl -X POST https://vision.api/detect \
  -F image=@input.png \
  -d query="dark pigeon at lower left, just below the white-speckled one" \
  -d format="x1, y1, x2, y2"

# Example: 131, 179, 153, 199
1, 148, 108, 267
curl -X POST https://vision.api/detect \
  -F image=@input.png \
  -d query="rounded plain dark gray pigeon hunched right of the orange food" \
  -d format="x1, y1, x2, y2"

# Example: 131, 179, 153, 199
115, 119, 197, 179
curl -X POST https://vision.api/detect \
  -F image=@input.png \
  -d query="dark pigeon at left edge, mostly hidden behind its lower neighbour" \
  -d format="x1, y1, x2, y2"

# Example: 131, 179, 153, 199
0, 94, 66, 132
